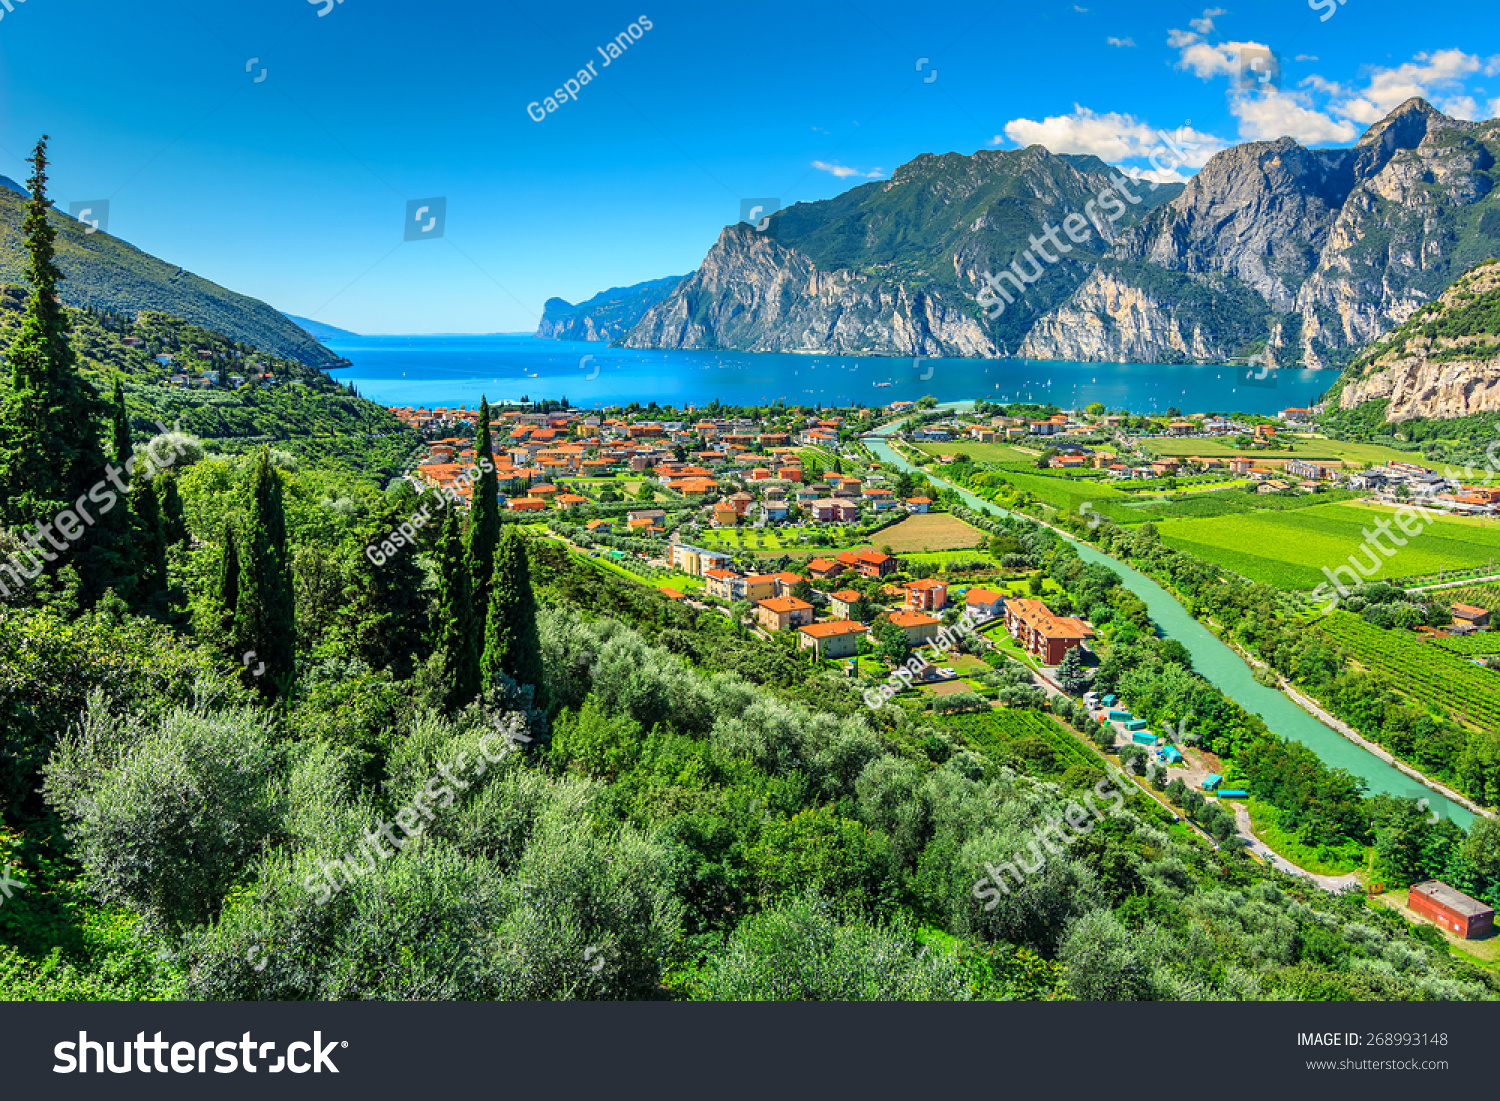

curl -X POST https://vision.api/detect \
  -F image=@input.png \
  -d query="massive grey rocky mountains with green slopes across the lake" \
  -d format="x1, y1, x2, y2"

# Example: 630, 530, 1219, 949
542, 99, 1500, 390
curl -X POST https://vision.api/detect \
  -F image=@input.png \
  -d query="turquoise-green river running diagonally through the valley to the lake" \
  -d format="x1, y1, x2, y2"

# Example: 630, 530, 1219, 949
864, 422, 1475, 830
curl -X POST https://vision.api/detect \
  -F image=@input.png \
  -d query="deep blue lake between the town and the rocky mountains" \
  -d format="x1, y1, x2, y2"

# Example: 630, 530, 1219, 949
327, 335, 1337, 413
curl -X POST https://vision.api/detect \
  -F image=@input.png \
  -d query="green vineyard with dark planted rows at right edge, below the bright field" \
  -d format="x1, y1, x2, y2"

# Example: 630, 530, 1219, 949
1320, 612, 1500, 732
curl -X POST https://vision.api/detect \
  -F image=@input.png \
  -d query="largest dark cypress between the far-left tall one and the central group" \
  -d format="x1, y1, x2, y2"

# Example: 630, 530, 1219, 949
231, 447, 297, 699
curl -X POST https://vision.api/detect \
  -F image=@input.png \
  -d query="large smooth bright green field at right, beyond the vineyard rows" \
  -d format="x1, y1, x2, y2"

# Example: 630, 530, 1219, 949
1152, 504, 1500, 590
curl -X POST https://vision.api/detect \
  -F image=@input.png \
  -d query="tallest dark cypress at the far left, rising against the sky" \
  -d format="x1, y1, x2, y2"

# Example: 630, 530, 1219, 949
0, 135, 104, 539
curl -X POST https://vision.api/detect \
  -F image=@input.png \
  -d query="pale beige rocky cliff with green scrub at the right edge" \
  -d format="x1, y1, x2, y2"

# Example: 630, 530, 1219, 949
1338, 261, 1500, 422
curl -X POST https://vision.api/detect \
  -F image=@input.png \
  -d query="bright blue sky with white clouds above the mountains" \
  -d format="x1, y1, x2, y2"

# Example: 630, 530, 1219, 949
0, 0, 1500, 333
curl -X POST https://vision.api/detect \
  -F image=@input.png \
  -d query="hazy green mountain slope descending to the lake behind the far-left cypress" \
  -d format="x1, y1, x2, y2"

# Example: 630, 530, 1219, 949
0, 180, 345, 368
